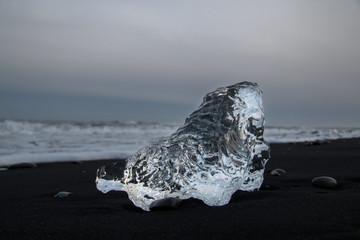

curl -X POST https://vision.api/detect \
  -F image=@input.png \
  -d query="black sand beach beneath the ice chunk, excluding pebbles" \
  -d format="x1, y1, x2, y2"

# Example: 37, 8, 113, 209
0, 139, 360, 240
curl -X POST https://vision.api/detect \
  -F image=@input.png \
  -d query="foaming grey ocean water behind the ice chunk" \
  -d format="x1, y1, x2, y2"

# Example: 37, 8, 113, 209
0, 120, 360, 166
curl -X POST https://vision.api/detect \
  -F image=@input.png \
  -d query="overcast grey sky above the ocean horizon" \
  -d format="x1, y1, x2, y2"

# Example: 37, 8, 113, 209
0, 0, 360, 127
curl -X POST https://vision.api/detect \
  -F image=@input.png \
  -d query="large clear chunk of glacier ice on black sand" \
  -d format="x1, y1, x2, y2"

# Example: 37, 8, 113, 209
96, 82, 270, 211
